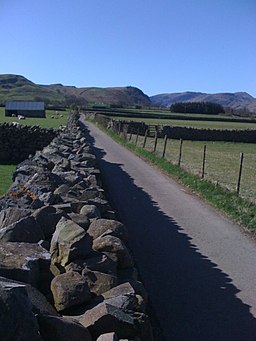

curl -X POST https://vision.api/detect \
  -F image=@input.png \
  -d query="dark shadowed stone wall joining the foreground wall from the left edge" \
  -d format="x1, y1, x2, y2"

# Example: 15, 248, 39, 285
0, 123, 58, 163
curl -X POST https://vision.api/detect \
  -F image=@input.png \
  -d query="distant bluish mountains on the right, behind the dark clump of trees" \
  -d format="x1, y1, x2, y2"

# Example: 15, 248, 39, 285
150, 91, 256, 112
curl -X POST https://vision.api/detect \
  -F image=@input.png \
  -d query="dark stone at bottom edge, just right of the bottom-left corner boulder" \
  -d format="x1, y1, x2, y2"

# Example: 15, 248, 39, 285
37, 314, 92, 341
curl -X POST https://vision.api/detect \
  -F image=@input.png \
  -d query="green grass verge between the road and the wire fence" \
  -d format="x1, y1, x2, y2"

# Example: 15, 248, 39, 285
90, 122, 256, 232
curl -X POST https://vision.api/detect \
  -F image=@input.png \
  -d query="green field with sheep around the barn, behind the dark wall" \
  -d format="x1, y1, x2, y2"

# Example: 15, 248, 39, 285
0, 107, 68, 128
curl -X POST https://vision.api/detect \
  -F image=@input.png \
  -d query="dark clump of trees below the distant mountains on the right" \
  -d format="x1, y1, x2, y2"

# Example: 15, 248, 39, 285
170, 102, 225, 115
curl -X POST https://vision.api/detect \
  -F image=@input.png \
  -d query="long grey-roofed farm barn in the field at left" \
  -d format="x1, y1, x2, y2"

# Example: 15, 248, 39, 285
5, 101, 45, 117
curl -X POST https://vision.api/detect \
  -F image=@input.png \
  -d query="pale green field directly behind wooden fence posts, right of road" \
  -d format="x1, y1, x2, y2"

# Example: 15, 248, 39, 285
131, 135, 256, 201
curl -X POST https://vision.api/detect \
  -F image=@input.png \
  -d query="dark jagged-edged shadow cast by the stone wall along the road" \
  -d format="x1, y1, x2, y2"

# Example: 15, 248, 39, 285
80, 121, 256, 341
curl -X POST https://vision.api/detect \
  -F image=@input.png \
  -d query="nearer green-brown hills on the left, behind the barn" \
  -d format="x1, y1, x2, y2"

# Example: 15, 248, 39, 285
0, 75, 151, 106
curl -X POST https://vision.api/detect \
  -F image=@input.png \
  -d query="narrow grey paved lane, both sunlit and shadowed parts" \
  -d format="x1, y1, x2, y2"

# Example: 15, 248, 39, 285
81, 119, 256, 341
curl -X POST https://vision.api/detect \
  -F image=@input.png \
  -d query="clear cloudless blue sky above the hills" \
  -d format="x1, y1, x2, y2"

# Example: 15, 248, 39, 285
0, 0, 256, 97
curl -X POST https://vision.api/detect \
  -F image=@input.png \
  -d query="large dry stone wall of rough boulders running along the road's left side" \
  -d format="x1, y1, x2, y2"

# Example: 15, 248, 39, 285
0, 115, 153, 341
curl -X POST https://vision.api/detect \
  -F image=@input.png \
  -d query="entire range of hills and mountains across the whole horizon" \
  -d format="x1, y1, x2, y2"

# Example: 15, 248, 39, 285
0, 74, 256, 113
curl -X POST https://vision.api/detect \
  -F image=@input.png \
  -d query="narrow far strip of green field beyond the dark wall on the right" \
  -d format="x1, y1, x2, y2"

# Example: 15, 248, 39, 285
113, 114, 256, 130
